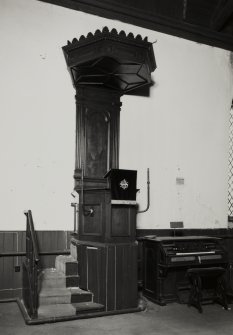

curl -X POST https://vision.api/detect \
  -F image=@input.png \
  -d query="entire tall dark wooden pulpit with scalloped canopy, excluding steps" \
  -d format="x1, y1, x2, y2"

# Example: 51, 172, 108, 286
63, 27, 156, 311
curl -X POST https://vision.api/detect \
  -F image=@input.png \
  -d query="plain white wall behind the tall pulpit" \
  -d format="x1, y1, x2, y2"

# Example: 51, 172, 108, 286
0, 0, 233, 230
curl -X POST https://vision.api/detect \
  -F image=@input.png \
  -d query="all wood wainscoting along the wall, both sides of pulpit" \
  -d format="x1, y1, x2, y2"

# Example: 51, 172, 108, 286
0, 229, 233, 300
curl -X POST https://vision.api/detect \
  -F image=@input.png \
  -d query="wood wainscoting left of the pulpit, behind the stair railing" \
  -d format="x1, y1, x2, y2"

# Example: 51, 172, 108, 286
0, 231, 71, 300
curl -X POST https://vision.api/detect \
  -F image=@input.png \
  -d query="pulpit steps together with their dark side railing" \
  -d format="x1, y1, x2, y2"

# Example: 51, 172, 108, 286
21, 210, 105, 324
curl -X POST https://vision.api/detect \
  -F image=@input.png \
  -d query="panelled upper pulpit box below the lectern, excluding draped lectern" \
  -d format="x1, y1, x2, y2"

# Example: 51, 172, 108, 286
78, 189, 137, 243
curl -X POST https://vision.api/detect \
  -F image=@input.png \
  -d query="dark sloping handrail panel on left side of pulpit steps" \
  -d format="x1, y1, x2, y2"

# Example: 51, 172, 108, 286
23, 210, 40, 319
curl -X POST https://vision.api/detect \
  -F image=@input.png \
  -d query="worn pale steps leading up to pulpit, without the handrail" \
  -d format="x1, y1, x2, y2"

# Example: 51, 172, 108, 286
38, 255, 104, 319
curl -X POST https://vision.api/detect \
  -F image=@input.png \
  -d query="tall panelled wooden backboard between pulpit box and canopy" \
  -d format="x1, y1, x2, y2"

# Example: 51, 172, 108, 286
74, 85, 121, 190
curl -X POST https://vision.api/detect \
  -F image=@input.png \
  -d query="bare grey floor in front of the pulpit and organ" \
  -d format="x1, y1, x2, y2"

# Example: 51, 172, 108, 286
0, 302, 233, 335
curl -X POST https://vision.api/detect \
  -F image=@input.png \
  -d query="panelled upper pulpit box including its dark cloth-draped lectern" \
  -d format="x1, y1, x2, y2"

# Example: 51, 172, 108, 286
78, 169, 137, 243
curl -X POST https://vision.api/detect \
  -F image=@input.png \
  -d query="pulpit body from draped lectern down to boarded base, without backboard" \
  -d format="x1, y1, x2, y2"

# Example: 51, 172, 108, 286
72, 169, 138, 310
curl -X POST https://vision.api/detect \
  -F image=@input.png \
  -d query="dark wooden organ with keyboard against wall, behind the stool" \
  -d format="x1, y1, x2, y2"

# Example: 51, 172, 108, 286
143, 236, 228, 305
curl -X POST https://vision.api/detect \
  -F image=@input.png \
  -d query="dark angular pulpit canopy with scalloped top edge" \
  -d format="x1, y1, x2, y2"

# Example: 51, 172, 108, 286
62, 27, 156, 94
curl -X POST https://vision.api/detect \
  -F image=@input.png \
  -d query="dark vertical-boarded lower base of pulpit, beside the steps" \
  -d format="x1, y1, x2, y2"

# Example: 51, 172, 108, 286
72, 239, 138, 311
